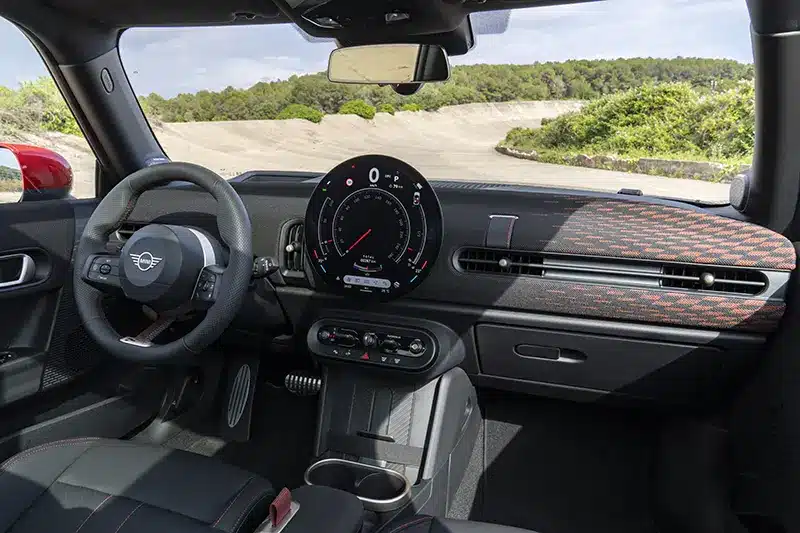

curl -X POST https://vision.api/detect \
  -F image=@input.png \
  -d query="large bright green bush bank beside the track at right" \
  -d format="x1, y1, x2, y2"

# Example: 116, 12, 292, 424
503, 82, 755, 162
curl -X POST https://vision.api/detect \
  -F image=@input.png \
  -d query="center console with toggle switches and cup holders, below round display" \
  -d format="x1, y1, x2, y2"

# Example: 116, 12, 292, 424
305, 311, 481, 524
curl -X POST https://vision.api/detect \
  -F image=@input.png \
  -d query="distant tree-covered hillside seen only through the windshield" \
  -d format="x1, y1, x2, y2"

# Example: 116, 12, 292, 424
140, 58, 753, 122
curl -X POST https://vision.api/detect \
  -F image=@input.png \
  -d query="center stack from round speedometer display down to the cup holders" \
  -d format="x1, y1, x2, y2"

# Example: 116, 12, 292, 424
300, 168, 480, 525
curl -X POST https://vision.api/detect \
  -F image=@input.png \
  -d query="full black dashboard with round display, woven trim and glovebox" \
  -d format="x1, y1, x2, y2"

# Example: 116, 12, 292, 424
122, 156, 796, 405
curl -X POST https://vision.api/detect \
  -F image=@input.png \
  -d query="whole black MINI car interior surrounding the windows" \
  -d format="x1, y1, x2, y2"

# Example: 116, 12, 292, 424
0, 0, 800, 533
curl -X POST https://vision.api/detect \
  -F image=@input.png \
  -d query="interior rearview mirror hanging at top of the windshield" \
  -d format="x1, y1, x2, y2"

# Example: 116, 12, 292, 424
328, 44, 450, 84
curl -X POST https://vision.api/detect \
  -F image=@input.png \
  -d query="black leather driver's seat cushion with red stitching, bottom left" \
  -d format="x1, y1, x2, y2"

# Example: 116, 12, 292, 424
0, 439, 275, 533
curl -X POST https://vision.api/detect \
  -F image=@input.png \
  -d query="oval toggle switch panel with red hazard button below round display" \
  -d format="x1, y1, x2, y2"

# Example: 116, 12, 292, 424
308, 320, 436, 371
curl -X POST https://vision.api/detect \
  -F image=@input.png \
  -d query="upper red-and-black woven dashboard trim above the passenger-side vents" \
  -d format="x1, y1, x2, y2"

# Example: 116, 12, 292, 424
512, 196, 796, 270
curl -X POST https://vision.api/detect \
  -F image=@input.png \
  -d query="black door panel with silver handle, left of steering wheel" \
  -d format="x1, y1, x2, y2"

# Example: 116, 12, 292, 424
0, 200, 91, 405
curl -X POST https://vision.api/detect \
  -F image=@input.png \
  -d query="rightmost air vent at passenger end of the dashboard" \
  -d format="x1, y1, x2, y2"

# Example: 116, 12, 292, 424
661, 265, 767, 295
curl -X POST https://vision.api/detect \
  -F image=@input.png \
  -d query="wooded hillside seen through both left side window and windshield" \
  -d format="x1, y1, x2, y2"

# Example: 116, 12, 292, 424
0, 58, 753, 137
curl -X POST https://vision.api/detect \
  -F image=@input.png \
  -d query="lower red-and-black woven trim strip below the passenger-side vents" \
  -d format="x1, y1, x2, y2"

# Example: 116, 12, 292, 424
535, 280, 786, 333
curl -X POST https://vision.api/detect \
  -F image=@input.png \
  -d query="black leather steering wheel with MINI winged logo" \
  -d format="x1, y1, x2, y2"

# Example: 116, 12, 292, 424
73, 163, 253, 363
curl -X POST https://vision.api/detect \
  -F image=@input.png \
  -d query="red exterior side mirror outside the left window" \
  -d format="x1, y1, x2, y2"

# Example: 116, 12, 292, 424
0, 143, 72, 203
